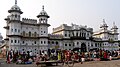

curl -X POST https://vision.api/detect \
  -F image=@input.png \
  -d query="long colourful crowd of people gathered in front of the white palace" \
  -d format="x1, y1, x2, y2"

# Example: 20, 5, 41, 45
6, 50, 120, 64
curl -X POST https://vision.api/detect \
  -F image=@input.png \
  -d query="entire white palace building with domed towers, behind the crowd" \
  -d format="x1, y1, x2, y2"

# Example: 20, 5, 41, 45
4, 2, 118, 54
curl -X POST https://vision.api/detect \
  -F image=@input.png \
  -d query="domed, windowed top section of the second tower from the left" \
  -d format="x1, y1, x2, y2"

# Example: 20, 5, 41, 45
37, 6, 49, 24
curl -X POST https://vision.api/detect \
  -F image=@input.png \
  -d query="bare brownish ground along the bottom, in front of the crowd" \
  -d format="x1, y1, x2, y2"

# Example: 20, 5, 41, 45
0, 60, 120, 67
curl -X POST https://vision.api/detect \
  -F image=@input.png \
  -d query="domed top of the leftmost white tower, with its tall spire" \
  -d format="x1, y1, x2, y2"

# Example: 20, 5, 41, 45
8, 0, 23, 20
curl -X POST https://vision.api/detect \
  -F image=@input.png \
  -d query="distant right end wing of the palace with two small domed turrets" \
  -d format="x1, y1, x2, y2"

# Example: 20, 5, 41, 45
93, 19, 120, 50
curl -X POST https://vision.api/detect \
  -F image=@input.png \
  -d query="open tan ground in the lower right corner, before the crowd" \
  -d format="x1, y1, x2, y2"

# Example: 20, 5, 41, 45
74, 60, 120, 67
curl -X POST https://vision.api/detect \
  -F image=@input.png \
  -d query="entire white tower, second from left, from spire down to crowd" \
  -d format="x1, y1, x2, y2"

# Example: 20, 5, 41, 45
37, 6, 50, 50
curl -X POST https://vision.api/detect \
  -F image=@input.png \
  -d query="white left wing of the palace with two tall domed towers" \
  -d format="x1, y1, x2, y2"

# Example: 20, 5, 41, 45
4, 0, 50, 53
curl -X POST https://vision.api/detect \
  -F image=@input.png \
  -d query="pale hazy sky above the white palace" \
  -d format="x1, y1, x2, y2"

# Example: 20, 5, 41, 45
0, 0, 120, 38
